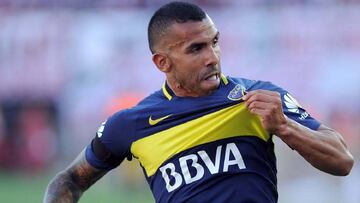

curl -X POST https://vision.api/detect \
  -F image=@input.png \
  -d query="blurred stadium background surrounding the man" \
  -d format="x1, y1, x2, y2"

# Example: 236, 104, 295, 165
0, 0, 360, 203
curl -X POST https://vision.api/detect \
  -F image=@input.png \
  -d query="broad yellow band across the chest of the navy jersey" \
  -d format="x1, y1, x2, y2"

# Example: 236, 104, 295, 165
131, 103, 270, 177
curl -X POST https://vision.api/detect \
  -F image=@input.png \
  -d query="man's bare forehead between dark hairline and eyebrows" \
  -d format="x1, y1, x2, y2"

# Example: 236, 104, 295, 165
168, 17, 218, 47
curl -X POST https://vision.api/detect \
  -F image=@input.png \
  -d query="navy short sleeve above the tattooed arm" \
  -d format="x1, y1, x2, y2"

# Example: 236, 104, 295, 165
85, 110, 133, 170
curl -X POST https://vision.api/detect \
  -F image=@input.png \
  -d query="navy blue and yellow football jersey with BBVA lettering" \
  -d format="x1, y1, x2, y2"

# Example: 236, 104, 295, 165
86, 75, 320, 203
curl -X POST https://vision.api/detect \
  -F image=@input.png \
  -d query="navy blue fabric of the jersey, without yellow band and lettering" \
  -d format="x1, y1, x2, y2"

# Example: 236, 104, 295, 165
86, 77, 320, 203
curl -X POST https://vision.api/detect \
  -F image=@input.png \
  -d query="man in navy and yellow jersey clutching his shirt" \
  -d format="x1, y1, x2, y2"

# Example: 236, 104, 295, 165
44, 2, 353, 203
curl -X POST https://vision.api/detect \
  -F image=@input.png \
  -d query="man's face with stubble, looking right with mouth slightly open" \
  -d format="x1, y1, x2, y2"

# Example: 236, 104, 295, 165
158, 17, 221, 96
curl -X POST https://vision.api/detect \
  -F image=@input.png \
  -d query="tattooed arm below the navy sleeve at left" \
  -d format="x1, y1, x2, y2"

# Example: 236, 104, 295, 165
44, 150, 107, 203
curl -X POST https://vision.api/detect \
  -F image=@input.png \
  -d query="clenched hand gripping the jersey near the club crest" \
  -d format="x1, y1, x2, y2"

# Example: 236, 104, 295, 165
244, 90, 287, 135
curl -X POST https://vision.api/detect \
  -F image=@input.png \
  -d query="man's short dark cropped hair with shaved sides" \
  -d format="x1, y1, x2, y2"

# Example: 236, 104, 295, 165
148, 1, 206, 53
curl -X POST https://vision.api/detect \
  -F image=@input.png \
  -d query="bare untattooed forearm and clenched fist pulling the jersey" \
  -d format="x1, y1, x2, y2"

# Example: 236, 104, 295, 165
244, 90, 354, 176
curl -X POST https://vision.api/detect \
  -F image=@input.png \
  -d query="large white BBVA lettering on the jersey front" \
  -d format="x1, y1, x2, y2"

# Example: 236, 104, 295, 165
159, 143, 246, 192
